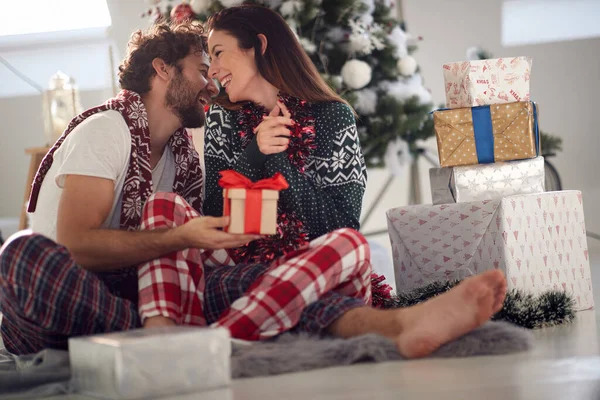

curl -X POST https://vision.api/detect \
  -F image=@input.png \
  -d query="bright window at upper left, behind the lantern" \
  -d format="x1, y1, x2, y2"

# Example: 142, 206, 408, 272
0, 0, 118, 98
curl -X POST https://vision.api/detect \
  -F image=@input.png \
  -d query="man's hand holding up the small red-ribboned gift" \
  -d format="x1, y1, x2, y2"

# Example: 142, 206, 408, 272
176, 217, 261, 249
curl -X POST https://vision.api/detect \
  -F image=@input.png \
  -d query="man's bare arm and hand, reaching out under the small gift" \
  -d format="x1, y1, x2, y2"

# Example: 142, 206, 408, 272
57, 175, 257, 272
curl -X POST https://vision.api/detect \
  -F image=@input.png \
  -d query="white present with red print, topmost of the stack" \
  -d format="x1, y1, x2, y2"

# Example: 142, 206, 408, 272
443, 57, 531, 108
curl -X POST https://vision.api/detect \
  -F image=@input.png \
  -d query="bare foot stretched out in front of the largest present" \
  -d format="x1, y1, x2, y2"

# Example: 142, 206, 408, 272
396, 270, 506, 358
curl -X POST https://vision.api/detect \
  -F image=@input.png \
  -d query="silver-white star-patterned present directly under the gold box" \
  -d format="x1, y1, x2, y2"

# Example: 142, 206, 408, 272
429, 157, 545, 204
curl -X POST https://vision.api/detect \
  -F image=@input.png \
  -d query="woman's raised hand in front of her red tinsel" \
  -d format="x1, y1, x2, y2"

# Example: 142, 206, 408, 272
254, 101, 295, 154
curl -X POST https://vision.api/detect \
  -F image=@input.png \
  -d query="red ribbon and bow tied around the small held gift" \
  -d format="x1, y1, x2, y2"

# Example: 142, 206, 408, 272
219, 170, 289, 234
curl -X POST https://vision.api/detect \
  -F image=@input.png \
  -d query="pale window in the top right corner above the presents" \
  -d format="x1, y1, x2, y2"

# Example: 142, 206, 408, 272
502, 0, 600, 46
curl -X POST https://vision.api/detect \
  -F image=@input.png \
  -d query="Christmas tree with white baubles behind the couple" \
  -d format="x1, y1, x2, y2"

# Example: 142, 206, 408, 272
144, 0, 433, 167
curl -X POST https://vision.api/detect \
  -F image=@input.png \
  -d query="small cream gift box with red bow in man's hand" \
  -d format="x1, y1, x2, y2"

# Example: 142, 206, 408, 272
219, 170, 289, 235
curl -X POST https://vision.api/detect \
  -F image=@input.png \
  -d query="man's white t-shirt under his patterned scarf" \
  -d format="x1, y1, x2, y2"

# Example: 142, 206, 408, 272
31, 110, 175, 241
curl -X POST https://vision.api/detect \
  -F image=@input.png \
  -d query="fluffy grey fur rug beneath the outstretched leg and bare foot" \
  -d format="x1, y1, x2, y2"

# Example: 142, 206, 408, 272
231, 322, 533, 378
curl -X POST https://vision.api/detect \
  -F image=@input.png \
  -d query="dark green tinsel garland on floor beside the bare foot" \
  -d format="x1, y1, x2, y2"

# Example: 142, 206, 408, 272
379, 281, 575, 329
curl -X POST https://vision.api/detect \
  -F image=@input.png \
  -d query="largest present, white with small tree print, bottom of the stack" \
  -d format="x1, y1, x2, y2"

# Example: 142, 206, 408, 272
387, 191, 594, 310
